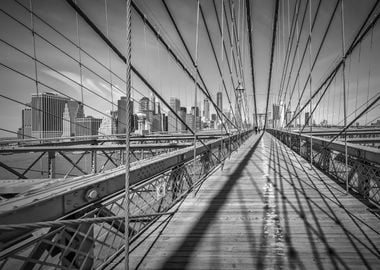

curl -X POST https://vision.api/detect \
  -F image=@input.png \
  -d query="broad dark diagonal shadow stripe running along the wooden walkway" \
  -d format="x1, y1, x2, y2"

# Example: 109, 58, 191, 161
157, 135, 262, 270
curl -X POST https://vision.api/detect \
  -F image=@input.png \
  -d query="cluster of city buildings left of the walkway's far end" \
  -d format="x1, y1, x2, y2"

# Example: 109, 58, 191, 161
15, 92, 238, 139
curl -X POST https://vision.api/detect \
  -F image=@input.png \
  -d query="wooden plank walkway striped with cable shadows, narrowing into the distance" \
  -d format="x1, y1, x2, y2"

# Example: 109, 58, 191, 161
121, 134, 380, 270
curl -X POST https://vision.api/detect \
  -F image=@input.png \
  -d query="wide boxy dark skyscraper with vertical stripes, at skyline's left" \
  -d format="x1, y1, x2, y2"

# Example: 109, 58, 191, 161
31, 92, 69, 138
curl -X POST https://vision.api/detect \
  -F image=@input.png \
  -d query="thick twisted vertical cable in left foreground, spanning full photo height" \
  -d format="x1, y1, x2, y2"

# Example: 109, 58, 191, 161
124, 0, 132, 270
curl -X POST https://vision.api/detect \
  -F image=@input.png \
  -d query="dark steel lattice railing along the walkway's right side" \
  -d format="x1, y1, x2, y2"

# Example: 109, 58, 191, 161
267, 129, 380, 206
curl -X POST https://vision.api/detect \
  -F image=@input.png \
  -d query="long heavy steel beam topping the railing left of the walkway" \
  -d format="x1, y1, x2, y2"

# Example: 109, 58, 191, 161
0, 131, 252, 242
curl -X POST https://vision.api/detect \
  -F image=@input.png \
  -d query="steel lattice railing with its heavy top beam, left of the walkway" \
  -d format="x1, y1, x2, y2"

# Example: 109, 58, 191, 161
0, 131, 251, 269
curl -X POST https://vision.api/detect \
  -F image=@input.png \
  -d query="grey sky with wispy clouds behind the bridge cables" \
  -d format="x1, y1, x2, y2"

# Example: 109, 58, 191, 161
0, 0, 380, 137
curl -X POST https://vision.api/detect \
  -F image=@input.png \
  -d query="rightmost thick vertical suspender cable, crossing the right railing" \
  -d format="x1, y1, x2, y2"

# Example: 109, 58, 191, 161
340, 0, 348, 194
